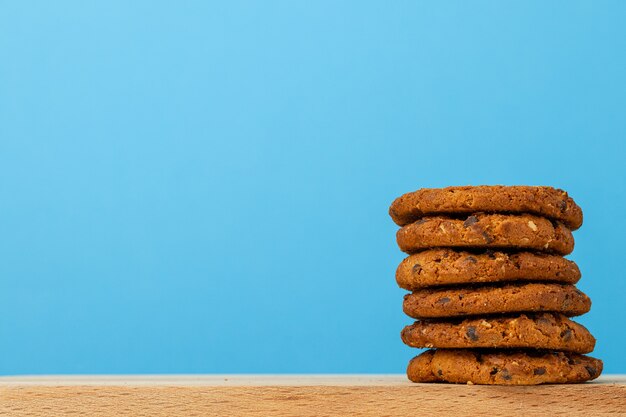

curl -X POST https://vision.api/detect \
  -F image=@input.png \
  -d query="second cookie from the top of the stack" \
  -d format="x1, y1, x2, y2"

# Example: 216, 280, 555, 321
396, 213, 574, 255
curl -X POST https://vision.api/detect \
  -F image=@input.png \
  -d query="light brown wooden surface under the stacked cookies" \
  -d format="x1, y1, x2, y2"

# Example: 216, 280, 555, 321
0, 375, 626, 417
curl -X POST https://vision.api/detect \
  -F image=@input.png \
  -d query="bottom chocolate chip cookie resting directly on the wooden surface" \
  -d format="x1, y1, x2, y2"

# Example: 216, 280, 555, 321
407, 349, 602, 385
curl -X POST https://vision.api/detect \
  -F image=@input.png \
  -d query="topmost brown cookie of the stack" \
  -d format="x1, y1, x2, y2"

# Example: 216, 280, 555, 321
389, 185, 583, 230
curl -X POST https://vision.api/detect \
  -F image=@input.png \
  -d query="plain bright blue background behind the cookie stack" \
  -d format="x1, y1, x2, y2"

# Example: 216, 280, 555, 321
0, 1, 626, 374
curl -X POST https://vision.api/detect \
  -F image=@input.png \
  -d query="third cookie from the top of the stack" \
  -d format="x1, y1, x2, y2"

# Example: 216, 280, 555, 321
396, 249, 580, 291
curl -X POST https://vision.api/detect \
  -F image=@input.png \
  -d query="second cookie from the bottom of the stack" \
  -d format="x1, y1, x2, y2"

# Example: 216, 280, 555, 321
401, 313, 596, 353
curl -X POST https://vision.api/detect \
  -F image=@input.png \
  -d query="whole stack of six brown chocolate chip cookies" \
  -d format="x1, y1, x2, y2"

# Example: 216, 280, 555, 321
389, 186, 602, 385
